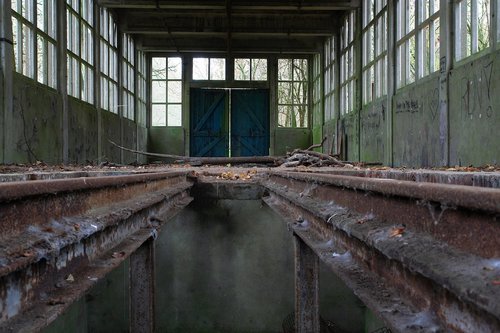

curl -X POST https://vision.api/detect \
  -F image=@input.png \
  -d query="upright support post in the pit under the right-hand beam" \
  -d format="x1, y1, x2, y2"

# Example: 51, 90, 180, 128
295, 236, 320, 333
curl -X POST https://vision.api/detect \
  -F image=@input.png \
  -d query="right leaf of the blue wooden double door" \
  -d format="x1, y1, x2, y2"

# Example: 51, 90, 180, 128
231, 89, 269, 156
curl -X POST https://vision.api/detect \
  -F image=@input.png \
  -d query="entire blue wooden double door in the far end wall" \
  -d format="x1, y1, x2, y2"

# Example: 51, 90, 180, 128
190, 89, 269, 156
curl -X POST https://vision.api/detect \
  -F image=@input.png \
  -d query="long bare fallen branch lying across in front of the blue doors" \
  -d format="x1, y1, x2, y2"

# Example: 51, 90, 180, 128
108, 139, 283, 166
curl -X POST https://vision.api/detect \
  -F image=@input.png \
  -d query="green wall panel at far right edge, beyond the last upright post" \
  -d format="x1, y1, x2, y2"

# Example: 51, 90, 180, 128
449, 51, 500, 166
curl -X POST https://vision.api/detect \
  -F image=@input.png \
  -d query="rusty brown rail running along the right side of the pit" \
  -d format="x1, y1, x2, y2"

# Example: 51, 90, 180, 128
270, 171, 500, 213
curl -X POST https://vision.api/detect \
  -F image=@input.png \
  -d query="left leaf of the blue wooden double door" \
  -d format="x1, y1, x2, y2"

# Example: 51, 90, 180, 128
190, 89, 228, 156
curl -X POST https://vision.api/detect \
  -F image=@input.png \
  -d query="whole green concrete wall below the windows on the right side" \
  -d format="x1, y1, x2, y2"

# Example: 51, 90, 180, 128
314, 50, 500, 168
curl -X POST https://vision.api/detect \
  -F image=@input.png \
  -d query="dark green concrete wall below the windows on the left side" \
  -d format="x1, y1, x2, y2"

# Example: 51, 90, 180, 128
0, 73, 147, 164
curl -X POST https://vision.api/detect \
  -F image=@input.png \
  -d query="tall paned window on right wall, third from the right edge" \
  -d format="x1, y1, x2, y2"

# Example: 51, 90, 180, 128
363, 0, 387, 104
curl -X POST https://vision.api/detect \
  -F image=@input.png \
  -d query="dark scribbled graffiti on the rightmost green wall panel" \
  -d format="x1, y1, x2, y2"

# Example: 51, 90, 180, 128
460, 61, 493, 119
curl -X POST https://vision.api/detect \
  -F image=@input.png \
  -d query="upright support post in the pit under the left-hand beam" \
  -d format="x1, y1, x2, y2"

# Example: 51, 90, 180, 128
129, 238, 155, 333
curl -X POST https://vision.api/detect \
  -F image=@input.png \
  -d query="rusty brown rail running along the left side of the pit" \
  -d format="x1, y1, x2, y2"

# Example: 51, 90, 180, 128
0, 170, 189, 201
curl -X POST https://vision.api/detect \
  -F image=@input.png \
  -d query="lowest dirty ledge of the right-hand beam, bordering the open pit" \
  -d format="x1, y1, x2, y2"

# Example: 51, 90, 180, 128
263, 195, 440, 333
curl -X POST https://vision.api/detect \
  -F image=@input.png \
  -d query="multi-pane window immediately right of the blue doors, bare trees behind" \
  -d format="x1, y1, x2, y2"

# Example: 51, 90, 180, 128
278, 59, 309, 127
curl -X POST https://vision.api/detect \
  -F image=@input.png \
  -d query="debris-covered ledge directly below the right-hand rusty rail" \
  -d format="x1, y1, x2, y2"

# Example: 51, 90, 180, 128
266, 184, 500, 318
